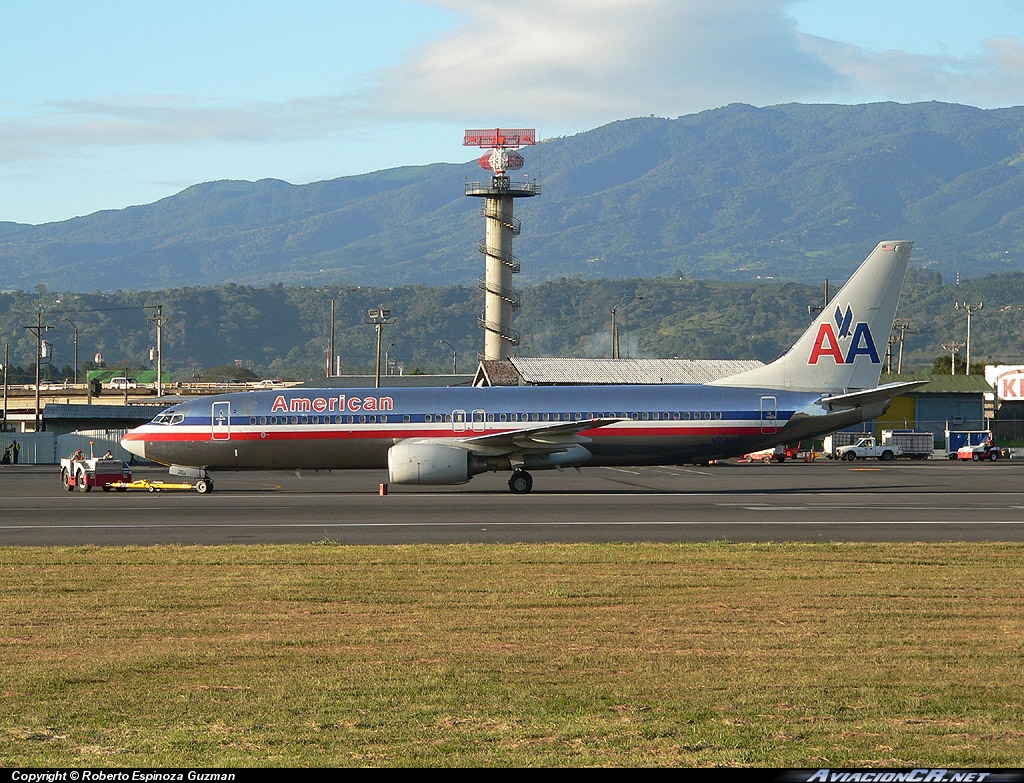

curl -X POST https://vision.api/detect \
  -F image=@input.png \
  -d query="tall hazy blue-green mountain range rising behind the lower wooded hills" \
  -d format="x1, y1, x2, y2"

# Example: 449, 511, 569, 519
0, 102, 1024, 292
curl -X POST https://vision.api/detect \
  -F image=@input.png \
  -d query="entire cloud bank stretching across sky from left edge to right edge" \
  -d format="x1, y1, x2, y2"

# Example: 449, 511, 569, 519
0, 0, 1024, 169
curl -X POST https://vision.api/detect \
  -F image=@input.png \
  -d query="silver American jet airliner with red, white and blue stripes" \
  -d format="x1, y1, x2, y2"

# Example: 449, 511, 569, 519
121, 241, 921, 494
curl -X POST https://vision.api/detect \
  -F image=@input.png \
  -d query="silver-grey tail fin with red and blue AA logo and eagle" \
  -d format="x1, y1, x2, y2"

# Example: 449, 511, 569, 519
713, 241, 913, 394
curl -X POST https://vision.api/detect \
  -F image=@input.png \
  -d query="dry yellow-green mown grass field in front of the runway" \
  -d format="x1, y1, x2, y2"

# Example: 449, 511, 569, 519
0, 541, 1024, 768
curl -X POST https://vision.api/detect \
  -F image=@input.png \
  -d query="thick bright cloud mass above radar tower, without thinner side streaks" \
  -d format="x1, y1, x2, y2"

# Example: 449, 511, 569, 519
364, 0, 843, 124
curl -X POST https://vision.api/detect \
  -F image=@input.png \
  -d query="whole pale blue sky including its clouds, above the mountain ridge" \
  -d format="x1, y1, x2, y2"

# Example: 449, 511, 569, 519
0, 0, 1024, 223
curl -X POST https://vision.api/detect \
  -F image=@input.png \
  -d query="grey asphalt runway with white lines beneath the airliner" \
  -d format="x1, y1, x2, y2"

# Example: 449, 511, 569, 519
0, 460, 1024, 546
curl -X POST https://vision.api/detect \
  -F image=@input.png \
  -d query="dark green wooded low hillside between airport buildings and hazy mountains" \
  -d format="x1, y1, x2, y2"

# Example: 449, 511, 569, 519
0, 264, 1024, 380
